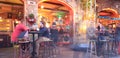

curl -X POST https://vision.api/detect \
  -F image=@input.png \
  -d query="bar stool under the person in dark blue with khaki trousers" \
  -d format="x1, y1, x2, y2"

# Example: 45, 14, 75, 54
38, 37, 56, 58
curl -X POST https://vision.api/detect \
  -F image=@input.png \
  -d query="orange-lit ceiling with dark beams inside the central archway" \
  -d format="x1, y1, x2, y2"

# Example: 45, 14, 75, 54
38, 1, 69, 15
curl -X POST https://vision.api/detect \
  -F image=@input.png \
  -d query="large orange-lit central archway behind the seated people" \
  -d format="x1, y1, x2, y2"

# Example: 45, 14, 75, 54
38, 0, 73, 34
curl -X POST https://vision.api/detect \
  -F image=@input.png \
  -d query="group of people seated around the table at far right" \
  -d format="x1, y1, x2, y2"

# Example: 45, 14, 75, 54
89, 23, 120, 56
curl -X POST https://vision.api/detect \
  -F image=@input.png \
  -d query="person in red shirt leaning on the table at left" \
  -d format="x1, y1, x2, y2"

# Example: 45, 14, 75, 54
11, 20, 28, 42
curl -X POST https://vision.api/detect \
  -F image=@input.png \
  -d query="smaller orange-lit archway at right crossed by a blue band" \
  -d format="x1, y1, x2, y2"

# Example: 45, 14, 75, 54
98, 8, 119, 26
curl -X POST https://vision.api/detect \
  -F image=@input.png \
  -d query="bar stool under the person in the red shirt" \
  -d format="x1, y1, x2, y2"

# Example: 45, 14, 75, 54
14, 38, 31, 58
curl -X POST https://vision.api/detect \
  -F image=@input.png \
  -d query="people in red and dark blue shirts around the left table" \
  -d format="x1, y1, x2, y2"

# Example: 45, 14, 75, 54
11, 20, 69, 56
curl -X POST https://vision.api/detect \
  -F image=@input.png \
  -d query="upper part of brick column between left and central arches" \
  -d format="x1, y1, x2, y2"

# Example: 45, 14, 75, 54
22, 0, 39, 26
